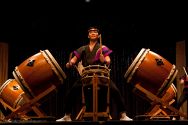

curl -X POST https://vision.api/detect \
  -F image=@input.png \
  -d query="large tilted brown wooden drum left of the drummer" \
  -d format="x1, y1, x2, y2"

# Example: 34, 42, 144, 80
13, 50, 66, 97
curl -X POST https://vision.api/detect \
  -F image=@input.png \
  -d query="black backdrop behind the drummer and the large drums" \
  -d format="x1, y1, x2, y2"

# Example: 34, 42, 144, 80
0, 0, 188, 120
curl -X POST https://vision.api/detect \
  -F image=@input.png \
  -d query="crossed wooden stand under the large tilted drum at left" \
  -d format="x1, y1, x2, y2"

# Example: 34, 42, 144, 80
3, 85, 56, 120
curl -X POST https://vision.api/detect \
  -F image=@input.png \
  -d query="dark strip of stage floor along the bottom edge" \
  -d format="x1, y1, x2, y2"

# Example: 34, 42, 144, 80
0, 120, 188, 125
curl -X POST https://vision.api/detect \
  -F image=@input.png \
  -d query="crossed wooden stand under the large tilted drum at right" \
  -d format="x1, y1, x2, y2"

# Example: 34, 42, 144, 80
135, 83, 187, 119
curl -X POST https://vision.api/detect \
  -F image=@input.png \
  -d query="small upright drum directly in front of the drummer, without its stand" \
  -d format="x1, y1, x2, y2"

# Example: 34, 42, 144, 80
81, 65, 110, 85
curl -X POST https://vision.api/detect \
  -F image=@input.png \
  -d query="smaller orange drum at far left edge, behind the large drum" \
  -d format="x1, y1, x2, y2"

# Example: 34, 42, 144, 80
0, 79, 24, 109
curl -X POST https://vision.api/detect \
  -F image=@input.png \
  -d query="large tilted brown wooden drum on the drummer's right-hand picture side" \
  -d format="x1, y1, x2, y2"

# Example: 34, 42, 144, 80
124, 48, 178, 97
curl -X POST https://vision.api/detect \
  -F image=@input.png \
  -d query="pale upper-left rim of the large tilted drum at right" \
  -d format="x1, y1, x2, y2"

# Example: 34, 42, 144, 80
124, 49, 150, 83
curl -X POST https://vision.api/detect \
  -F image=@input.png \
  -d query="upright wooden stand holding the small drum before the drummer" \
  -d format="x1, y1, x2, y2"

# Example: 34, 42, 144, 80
76, 74, 112, 121
